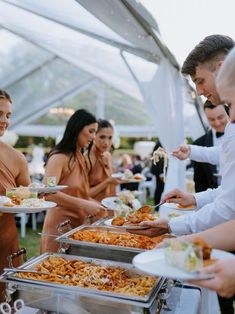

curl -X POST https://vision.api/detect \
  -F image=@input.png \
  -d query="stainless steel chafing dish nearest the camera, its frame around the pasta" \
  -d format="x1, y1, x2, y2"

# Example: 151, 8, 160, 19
0, 253, 168, 314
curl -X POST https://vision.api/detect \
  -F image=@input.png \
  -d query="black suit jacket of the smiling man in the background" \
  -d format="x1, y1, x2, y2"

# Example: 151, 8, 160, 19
193, 130, 218, 192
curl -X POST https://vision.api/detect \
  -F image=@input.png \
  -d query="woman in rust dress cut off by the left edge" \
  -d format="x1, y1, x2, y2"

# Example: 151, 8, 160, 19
0, 90, 30, 303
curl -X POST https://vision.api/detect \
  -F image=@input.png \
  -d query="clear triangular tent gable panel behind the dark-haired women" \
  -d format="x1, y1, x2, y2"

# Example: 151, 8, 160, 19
31, 80, 149, 128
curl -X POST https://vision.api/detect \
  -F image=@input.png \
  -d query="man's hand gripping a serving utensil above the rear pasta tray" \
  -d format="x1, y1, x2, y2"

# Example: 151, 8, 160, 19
162, 189, 196, 206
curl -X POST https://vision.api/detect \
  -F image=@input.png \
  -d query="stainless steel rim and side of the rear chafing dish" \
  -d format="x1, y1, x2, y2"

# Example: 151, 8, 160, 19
56, 225, 152, 263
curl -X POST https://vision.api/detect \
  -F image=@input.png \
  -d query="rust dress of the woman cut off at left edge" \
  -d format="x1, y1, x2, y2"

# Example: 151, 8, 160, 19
0, 160, 19, 303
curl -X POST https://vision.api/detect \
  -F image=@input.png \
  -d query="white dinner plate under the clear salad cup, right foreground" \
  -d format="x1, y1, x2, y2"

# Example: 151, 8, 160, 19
132, 248, 235, 280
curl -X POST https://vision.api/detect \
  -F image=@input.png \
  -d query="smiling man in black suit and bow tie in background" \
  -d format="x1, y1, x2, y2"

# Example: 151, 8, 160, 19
193, 100, 229, 192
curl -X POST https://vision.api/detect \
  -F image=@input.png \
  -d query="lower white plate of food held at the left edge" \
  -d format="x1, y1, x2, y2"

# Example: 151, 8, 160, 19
0, 197, 57, 214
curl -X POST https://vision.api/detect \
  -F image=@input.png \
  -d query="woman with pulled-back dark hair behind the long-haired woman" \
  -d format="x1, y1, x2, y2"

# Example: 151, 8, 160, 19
85, 119, 123, 201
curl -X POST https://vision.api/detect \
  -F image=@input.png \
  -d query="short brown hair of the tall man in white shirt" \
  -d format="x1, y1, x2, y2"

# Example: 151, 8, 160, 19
181, 35, 235, 76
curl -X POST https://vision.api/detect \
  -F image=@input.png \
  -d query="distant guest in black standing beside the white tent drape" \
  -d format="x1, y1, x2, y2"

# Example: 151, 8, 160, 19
151, 140, 165, 205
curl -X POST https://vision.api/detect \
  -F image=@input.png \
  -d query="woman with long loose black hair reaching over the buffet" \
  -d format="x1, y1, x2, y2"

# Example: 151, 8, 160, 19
41, 109, 104, 252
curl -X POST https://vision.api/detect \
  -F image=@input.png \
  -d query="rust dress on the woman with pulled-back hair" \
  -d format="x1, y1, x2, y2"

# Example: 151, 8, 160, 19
88, 146, 116, 202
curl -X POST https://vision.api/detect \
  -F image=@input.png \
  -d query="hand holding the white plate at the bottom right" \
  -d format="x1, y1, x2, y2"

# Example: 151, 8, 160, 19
192, 258, 235, 298
